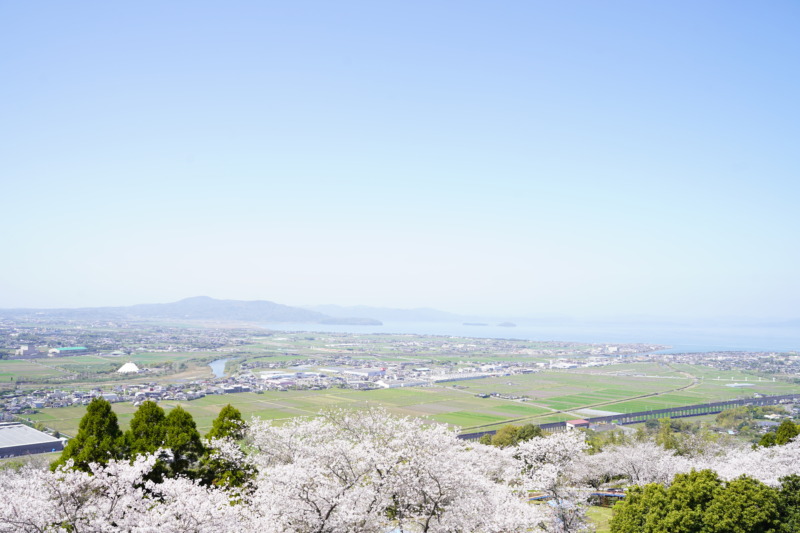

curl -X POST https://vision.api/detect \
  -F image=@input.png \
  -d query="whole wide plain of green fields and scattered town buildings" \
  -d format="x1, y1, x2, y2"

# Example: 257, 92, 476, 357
6, 324, 800, 435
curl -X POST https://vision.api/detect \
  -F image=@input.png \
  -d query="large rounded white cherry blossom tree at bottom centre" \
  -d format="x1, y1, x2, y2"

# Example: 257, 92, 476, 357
242, 409, 546, 533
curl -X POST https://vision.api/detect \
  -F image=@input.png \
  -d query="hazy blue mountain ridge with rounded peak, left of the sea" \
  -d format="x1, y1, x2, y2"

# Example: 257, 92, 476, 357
0, 296, 381, 326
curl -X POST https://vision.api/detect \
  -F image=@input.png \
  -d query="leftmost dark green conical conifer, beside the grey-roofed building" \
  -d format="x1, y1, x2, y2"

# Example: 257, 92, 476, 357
50, 398, 123, 472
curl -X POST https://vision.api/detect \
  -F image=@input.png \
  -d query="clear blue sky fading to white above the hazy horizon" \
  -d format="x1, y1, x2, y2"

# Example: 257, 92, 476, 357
0, 1, 800, 319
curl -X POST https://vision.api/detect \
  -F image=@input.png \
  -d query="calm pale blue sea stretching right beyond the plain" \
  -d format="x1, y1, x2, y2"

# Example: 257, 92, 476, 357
264, 322, 800, 353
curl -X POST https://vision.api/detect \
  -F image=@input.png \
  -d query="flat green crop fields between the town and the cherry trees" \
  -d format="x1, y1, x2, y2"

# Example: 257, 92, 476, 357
23, 363, 800, 435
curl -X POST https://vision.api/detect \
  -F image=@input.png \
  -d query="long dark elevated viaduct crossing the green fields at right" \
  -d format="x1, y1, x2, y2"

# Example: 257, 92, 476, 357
458, 394, 800, 440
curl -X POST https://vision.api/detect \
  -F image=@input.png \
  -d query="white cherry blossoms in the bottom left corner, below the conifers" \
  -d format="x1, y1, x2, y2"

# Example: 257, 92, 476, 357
0, 455, 241, 533
